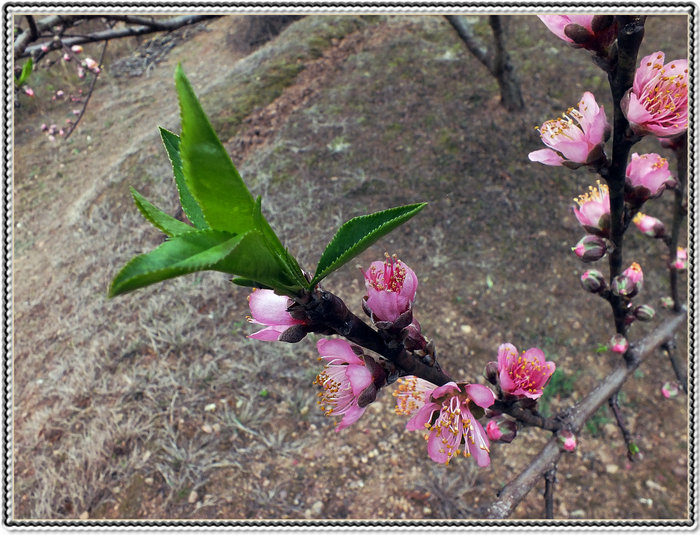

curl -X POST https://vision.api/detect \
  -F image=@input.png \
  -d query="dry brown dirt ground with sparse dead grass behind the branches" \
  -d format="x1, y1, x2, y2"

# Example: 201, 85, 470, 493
12, 15, 689, 520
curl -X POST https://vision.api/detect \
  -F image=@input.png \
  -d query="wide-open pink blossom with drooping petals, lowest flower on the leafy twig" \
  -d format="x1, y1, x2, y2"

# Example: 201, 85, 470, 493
394, 376, 495, 466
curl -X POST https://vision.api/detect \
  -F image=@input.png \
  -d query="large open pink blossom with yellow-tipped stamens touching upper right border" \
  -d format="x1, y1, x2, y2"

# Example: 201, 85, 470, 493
620, 52, 688, 137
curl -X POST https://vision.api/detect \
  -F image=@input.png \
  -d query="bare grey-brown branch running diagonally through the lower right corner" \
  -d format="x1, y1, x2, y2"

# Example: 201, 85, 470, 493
483, 307, 686, 518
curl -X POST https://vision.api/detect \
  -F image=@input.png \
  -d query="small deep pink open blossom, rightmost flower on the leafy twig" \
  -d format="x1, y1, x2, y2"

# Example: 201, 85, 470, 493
498, 344, 556, 399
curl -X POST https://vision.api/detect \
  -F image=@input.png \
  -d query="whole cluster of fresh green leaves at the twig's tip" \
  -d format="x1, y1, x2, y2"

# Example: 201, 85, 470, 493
109, 65, 425, 297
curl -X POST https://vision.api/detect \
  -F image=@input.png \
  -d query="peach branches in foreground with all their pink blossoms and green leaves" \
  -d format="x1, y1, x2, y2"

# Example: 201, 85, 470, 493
109, 10, 688, 517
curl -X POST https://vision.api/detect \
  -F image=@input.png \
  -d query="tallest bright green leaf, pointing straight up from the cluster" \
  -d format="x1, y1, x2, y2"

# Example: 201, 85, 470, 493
175, 65, 255, 234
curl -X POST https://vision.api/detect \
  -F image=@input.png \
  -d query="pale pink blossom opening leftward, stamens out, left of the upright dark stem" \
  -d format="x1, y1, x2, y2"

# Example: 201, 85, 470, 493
528, 91, 610, 169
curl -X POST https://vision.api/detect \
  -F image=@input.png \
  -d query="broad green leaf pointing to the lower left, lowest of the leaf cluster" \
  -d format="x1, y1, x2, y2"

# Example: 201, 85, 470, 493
109, 229, 243, 297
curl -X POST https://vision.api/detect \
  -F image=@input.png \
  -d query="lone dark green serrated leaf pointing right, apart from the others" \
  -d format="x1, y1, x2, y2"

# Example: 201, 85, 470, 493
311, 203, 427, 286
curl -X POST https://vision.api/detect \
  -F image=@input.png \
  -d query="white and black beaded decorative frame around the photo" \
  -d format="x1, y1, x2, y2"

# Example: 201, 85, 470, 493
0, 0, 700, 532
